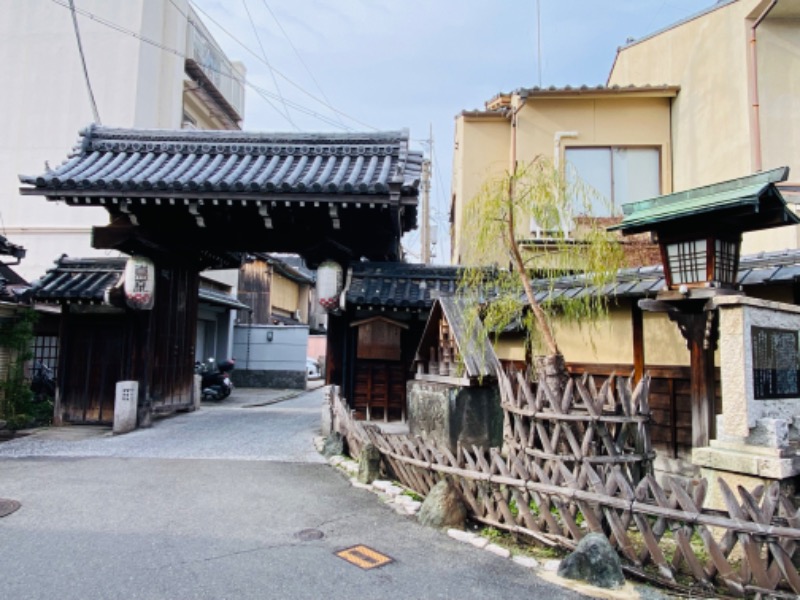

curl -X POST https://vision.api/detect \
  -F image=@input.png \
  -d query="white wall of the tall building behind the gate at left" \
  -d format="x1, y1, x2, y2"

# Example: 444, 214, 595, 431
0, 0, 188, 280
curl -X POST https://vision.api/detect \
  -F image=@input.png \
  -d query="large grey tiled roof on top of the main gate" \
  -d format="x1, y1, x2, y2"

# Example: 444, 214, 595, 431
20, 125, 422, 196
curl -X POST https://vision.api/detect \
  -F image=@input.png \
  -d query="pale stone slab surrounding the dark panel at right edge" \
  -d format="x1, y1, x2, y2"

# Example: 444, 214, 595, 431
719, 299, 800, 437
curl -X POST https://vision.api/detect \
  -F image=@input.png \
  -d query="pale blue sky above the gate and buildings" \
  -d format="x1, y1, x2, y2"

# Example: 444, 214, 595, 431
191, 0, 715, 264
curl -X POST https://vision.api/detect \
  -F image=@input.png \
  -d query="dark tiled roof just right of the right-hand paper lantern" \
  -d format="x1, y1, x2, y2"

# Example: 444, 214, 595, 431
346, 262, 458, 310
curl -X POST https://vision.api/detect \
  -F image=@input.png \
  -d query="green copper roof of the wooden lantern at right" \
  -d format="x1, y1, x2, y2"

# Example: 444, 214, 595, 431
609, 167, 800, 234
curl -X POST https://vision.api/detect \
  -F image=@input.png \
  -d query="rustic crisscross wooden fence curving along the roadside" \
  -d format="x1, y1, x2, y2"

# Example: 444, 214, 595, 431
330, 376, 800, 598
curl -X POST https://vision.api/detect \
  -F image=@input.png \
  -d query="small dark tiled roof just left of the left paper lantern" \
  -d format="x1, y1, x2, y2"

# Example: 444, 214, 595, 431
31, 256, 127, 304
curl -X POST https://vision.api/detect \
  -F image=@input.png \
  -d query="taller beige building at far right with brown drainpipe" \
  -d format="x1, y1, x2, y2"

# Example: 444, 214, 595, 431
608, 0, 800, 254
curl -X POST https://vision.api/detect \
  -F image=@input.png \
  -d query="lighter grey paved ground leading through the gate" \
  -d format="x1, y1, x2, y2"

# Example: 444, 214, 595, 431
0, 388, 324, 463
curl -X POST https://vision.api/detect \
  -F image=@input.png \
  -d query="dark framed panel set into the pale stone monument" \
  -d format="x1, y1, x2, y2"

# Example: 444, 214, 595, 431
751, 326, 800, 400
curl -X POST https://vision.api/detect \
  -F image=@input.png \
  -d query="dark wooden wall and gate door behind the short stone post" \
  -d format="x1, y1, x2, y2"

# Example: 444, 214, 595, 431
55, 267, 199, 426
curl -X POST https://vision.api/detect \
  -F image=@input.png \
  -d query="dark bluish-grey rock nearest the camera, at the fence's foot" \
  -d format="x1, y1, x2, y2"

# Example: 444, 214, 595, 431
558, 533, 625, 588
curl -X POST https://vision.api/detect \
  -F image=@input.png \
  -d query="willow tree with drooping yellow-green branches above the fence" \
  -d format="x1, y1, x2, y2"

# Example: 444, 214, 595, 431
459, 156, 623, 381
